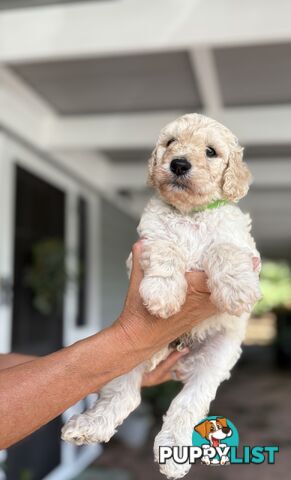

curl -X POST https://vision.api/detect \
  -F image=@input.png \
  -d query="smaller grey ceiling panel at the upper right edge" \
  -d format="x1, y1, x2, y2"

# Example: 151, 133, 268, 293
215, 44, 291, 106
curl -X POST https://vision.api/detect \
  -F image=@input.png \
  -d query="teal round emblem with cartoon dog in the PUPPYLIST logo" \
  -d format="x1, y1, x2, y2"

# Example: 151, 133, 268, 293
192, 416, 239, 465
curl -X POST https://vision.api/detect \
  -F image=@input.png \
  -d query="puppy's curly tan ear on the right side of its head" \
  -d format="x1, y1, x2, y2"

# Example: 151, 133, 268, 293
222, 145, 252, 202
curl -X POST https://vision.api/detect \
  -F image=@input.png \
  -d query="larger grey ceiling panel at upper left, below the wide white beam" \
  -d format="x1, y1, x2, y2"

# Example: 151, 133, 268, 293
11, 52, 200, 115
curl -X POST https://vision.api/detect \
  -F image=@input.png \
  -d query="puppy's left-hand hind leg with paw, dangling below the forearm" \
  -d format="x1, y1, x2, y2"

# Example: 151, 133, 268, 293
62, 364, 145, 445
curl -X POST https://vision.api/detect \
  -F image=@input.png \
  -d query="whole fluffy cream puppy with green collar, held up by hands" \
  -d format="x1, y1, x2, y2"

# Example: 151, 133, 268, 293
62, 114, 261, 478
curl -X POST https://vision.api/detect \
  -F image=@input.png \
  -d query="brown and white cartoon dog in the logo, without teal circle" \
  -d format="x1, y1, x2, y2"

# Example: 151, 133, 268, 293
194, 417, 232, 465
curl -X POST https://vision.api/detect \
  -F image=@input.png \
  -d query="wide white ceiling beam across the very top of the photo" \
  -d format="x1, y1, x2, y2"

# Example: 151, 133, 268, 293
0, 0, 291, 63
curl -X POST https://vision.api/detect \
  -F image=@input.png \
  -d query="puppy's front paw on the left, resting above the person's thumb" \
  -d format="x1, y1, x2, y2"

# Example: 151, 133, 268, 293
140, 275, 187, 318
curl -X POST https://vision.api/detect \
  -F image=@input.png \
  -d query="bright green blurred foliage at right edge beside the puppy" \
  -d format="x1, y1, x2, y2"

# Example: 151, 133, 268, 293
253, 261, 291, 315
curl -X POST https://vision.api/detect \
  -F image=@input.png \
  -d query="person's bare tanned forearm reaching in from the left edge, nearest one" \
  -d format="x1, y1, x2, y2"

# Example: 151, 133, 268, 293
0, 325, 146, 449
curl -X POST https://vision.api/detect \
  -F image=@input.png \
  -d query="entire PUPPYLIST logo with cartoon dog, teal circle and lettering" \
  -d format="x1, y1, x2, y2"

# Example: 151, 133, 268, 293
159, 416, 279, 465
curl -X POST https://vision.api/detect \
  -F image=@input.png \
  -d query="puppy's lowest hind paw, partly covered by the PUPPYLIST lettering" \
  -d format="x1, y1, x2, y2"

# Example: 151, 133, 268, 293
154, 430, 191, 479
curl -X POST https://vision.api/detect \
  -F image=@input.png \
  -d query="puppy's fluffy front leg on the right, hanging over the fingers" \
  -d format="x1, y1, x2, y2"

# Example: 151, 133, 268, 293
203, 243, 261, 316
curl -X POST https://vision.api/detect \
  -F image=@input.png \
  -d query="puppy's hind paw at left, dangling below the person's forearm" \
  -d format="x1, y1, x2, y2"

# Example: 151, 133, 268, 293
62, 413, 116, 445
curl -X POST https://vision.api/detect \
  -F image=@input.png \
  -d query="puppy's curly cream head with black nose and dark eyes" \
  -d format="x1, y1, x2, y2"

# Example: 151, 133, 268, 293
148, 114, 251, 213
